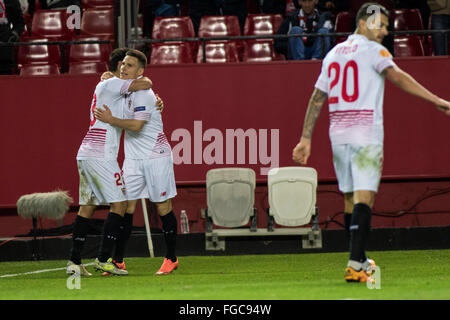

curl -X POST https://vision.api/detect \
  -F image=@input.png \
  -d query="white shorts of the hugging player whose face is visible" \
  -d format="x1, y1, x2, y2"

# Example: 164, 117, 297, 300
122, 156, 177, 202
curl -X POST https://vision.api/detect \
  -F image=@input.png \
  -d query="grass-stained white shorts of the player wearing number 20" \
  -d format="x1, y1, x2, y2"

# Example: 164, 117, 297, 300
332, 144, 383, 193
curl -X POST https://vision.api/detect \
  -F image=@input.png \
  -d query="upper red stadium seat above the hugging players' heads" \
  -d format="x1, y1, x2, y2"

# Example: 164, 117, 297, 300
80, 8, 114, 40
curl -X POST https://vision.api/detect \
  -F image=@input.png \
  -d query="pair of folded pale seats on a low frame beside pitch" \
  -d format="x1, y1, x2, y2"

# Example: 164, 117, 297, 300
205, 167, 322, 250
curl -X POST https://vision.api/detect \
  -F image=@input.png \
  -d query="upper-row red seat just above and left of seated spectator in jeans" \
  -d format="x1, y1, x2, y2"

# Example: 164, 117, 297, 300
244, 14, 283, 36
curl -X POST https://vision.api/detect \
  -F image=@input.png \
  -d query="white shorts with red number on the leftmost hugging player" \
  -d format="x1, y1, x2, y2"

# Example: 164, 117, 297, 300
77, 160, 127, 205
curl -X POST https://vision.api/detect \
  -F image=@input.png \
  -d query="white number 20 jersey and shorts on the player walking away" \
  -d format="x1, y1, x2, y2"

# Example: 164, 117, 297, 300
315, 34, 395, 193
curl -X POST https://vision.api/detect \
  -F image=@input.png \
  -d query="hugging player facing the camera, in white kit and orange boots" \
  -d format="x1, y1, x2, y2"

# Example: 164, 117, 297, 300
94, 50, 178, 274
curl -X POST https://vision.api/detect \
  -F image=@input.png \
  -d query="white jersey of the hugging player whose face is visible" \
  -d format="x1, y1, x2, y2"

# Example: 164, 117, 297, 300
123, 89, 172, 159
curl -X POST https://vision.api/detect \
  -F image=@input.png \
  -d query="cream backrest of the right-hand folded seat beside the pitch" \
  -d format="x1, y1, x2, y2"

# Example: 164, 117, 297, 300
267, 167, 317, 226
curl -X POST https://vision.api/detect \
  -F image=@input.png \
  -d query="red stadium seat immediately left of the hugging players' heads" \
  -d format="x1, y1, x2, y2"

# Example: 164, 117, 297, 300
69, 37, 111, 63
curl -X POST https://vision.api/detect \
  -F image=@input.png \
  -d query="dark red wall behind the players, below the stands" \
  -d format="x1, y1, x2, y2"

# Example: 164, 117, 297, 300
0, 57, 450, 236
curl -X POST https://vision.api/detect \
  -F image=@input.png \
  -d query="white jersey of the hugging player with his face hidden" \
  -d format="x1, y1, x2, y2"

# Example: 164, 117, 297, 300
77, 77, 133, 160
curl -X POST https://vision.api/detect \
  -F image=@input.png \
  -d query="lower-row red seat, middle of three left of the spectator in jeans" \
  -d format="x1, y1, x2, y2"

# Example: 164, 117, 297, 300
197, 41, 239, 63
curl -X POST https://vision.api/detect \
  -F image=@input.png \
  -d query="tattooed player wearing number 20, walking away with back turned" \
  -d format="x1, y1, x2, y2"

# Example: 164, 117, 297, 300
292, 3, 450, 282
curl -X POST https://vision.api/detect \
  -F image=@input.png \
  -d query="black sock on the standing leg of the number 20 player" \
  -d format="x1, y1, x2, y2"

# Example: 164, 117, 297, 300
350, 203, 372, 263
